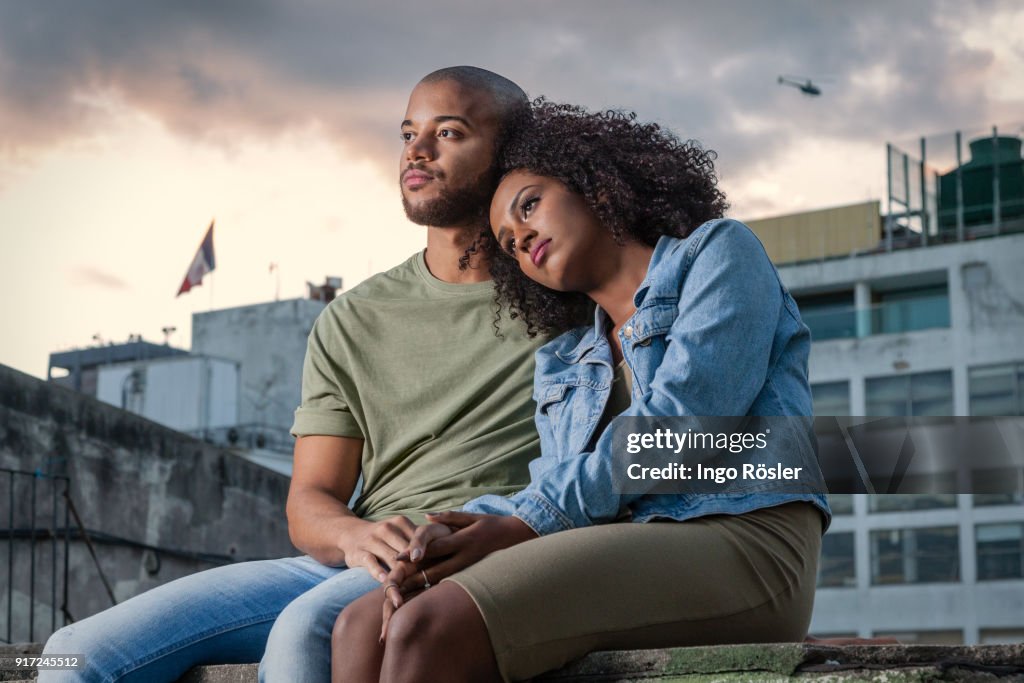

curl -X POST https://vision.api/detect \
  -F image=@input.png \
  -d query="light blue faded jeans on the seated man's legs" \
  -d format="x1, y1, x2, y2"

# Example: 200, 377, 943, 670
39, 557, 380, 683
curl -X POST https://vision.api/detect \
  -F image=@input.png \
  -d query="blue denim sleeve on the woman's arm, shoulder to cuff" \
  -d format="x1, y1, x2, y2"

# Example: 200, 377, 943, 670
477, 221, 785, 536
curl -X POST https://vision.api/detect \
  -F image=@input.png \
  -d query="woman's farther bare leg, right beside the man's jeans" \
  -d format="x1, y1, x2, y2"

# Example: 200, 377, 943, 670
331, 589, 385, 683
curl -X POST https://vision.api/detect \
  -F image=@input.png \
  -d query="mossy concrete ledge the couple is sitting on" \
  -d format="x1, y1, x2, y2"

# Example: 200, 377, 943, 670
0, 643, 1024, 683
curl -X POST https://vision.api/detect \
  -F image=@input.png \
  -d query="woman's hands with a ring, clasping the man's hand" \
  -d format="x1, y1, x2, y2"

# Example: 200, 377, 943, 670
381, 512, 537, 642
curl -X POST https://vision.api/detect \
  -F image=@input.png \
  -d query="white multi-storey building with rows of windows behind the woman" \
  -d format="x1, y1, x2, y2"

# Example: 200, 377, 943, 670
750, 147, 1024, 644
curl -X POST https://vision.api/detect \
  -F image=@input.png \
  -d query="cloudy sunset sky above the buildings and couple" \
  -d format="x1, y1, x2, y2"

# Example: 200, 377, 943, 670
0, 0, 1024, 376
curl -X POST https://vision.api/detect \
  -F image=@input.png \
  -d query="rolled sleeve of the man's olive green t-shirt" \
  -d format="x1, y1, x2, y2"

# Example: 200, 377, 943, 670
292, 311, 364, 438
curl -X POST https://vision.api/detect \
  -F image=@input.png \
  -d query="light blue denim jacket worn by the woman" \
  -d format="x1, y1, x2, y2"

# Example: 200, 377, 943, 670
464, 219, 831, 536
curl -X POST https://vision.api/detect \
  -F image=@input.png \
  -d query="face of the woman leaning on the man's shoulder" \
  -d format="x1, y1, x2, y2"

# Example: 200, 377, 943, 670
490, 170, 616, 292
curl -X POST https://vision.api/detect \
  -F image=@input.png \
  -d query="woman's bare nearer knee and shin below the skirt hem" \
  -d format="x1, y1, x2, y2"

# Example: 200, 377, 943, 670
378, 582, 502, 683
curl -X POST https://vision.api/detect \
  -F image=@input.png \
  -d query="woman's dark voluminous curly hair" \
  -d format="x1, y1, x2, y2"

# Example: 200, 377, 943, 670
474, 97, 728, 337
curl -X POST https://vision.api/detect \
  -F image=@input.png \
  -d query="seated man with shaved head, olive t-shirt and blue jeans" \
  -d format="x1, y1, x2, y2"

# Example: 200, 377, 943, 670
39, 67, 543, 683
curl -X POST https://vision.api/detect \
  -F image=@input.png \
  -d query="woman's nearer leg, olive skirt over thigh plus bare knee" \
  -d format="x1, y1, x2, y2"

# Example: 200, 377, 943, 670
372, 503, 821, 683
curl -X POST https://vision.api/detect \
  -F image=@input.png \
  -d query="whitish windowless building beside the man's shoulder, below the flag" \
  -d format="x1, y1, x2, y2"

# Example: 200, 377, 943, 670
48, 279, 341, 475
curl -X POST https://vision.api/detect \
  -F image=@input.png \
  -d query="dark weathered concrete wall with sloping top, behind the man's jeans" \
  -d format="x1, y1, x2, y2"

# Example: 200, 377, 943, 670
0, 366, 298, 640
